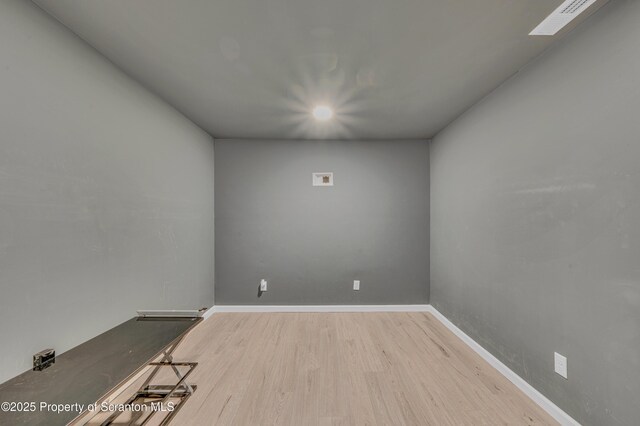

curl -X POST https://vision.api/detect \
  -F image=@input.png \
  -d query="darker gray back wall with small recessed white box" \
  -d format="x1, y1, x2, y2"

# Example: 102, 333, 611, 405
215, 139, 429, 305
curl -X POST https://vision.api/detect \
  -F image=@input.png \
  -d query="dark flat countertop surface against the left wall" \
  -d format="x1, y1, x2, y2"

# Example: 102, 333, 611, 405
0, 318, 201, 425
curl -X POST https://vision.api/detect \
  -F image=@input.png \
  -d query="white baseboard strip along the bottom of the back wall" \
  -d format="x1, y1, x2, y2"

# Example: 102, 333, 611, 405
210, 305, 429, 318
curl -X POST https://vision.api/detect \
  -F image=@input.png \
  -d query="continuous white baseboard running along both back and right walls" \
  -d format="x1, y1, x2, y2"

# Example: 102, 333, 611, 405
202, 305, 580, 426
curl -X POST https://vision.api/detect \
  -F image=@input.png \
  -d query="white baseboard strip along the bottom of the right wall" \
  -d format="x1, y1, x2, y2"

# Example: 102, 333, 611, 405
427, 305, 580, 426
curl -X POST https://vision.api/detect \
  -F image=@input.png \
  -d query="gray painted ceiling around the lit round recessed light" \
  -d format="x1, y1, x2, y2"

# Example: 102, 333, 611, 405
34, 0, 604, 139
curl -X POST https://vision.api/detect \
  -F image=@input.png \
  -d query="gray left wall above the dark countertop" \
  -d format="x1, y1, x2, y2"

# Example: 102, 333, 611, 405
0, 0, 214, 382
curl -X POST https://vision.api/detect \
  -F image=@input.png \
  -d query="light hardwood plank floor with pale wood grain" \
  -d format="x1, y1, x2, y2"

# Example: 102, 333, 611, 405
94, 313, 557, 426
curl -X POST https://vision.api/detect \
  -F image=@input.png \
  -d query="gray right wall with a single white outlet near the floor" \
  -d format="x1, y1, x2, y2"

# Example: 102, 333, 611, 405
431, 0, 640, 425
